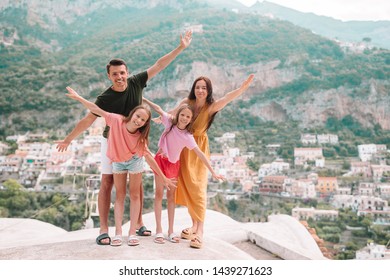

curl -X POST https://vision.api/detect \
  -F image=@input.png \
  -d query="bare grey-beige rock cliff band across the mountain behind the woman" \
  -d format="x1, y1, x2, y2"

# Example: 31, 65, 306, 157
146, 61, 390, 130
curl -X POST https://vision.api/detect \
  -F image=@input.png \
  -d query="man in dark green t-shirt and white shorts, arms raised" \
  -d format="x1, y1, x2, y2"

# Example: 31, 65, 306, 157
57, 31, 192, 245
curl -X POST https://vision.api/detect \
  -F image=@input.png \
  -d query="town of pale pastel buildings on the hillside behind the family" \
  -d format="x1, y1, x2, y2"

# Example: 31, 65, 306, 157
0, 125, 390, 259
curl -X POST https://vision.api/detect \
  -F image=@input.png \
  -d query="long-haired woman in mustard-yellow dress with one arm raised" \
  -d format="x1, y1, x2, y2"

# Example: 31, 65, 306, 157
174, 74, 254, 248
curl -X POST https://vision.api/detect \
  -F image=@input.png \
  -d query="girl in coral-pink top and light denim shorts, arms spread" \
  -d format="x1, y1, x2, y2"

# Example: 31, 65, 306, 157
66, 87, 176, 246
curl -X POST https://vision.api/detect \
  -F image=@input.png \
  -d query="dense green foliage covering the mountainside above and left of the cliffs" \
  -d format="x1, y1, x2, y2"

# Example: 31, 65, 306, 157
0, 6, 390, 137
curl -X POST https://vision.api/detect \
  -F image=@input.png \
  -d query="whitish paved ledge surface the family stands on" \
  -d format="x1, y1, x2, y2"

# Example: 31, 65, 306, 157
0, 207, 326, 260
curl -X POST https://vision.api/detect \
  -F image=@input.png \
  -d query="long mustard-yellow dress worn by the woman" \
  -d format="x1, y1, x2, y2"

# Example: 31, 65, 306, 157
176, 101, 210, 222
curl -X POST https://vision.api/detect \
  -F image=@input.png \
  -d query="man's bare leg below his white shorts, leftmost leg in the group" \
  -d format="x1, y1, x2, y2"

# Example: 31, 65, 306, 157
98, 174, 114, 244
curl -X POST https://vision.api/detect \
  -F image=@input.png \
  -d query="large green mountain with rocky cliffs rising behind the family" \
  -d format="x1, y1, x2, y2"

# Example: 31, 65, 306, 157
0, 0, 390, 145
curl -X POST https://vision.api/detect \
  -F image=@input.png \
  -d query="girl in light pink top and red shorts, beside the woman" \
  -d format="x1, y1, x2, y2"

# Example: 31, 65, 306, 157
143, 98, 224, 244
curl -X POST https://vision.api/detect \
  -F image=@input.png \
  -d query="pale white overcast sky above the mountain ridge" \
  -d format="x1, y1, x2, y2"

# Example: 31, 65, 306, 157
237, 0, 390, 21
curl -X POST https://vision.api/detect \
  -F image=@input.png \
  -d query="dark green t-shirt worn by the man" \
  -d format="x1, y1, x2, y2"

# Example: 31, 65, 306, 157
95, 71, 148, 138
